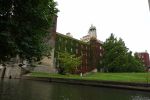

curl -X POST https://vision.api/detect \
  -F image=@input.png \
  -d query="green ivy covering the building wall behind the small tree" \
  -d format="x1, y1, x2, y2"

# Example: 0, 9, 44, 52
55, 33, 91, 73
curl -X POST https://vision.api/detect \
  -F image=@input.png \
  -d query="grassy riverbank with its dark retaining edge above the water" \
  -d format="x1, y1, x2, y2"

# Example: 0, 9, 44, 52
22, 73, 150, 91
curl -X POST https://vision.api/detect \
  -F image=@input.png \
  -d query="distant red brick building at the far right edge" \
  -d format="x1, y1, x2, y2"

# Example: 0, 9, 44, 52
135, 51, 150, 67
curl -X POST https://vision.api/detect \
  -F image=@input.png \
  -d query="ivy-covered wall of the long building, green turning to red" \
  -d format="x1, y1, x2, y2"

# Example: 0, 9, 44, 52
55, 33, 101, 73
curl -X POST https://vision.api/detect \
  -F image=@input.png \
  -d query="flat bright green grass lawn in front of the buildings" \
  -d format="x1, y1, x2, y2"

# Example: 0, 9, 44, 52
31, 72, 150, 83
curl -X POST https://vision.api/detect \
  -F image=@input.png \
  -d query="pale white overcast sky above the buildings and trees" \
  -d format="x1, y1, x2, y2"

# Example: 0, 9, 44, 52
55, 0, 150, 53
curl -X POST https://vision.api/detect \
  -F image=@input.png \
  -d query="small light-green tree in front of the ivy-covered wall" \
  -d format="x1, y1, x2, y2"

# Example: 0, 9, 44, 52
58, 52, 81, 74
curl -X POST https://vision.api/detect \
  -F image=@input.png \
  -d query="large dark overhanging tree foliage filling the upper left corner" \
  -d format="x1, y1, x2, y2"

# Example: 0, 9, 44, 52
0, 0, 58, 62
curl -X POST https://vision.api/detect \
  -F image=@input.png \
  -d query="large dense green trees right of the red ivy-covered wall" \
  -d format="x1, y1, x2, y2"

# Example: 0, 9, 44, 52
102, 34, 144, 72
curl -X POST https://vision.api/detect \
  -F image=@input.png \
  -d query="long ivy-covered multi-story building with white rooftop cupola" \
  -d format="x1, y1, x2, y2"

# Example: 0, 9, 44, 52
41, 16, 103, 73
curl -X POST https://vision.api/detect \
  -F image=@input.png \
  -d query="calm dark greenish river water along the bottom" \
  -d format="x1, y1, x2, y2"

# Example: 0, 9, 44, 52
0, 79, 150, 100
